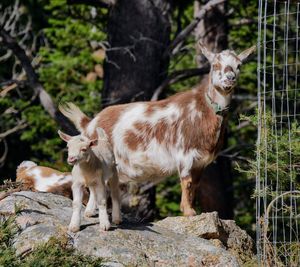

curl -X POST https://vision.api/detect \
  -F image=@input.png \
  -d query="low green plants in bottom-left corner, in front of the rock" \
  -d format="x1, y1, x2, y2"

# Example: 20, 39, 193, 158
0, 216, 102, 267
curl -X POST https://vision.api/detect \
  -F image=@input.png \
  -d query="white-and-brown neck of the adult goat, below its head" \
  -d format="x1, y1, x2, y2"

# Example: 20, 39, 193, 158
206, 74, 232, 111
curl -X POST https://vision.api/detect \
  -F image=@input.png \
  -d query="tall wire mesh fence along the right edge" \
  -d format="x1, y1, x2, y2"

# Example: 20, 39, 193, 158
256, 0, 300, 266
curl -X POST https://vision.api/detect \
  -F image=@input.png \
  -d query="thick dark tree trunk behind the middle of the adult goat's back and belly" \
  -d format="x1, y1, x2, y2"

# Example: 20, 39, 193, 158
102, 0, 170, 221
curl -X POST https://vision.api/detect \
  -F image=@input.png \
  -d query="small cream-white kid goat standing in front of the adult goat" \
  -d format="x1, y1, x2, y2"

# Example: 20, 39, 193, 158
58, 128, 121, 232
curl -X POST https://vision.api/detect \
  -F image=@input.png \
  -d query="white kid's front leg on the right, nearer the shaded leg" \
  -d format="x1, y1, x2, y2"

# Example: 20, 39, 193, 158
92, 179, 110, 231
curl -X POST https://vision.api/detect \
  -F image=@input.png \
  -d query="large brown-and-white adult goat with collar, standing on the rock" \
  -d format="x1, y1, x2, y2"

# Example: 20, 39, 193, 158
60, 44, 255, 216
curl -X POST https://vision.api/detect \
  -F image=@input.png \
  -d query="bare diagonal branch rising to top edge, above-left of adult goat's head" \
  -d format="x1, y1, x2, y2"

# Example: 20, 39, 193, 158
164, 0, 226, 57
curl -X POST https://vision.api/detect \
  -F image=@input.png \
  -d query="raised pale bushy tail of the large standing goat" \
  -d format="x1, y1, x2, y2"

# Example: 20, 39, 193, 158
58, 102, 91, 132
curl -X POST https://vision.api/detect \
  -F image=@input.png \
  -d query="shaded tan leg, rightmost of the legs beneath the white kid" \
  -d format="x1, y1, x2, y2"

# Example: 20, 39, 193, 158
109, 173, 122, 224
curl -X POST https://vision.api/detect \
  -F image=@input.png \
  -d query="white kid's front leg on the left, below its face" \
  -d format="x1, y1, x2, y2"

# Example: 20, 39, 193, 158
68, 181, 84, 233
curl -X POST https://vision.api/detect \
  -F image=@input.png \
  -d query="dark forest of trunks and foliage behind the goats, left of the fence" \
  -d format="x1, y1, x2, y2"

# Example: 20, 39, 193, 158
0, 0, 258, 232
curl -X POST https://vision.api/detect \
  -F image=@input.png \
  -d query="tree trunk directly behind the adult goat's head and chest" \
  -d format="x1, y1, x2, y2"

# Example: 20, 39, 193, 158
195, 1, 233, 219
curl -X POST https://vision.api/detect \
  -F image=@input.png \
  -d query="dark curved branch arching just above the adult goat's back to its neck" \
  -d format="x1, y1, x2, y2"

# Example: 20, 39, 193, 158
151, 64, 209, 101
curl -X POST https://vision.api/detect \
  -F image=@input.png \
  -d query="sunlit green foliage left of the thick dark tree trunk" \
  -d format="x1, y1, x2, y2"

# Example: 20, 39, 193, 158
0, 0, 106, 179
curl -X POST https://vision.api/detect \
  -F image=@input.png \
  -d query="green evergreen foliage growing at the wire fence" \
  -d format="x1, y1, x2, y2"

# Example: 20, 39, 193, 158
241, 111, 300, 196
